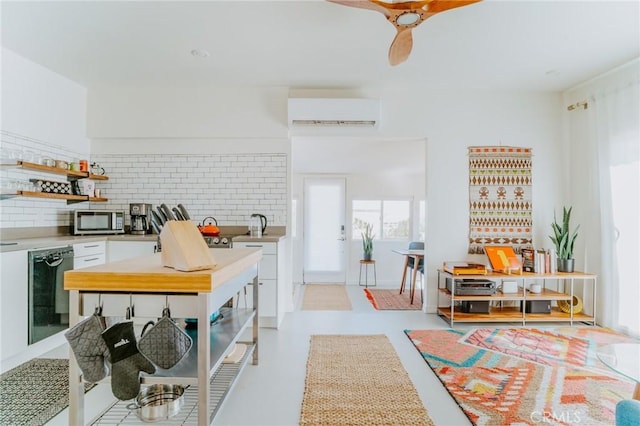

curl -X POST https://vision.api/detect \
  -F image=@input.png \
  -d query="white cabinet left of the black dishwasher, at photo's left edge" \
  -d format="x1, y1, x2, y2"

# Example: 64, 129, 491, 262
0, 250, 29, 360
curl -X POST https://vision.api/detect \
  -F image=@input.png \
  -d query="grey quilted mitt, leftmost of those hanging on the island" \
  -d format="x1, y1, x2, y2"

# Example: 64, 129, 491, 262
64, 313, 109, 382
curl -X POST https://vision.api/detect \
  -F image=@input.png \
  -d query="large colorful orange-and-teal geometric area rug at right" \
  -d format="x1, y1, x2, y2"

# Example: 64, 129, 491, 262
405, 327, 638, 425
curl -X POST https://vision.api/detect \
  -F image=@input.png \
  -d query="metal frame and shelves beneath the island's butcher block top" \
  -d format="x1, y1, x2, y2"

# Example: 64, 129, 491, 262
69, 266, 258, 425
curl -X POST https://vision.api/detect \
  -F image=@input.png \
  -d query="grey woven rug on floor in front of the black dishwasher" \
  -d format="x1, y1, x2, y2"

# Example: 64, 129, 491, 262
0, 358, 96, 426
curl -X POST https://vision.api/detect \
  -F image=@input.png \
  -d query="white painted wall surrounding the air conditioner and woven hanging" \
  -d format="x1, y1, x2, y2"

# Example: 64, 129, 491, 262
88, 87, 566, 311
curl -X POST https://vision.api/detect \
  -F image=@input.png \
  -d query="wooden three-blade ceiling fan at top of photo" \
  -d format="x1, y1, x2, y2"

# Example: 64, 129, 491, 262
327, 0, 481, 65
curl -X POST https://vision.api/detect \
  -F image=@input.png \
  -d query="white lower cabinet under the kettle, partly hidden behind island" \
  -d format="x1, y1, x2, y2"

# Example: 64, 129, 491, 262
233, 241, 283, 328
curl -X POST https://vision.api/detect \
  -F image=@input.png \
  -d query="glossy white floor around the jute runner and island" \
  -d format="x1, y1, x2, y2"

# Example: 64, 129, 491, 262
46, 286, 470, 426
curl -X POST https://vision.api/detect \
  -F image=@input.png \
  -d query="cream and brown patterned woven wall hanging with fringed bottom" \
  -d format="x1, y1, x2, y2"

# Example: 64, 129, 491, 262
469, 146, 533, 254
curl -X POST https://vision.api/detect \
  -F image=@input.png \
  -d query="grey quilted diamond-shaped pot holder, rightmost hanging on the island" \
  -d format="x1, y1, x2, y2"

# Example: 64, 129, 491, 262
138, 308, 193, 369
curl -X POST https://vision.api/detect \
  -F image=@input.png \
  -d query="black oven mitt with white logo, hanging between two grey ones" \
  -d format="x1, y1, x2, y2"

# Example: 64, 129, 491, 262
102, 321, 156, 401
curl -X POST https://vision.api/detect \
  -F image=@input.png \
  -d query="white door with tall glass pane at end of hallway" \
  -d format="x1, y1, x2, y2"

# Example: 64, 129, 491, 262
303, 178, 346, 284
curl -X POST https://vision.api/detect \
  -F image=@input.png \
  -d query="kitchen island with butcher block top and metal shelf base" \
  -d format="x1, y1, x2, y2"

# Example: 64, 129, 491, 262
64, 248, 262, 425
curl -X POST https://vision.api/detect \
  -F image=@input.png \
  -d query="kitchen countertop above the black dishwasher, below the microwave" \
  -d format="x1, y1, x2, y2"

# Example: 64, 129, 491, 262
0, 234, 158, 253
